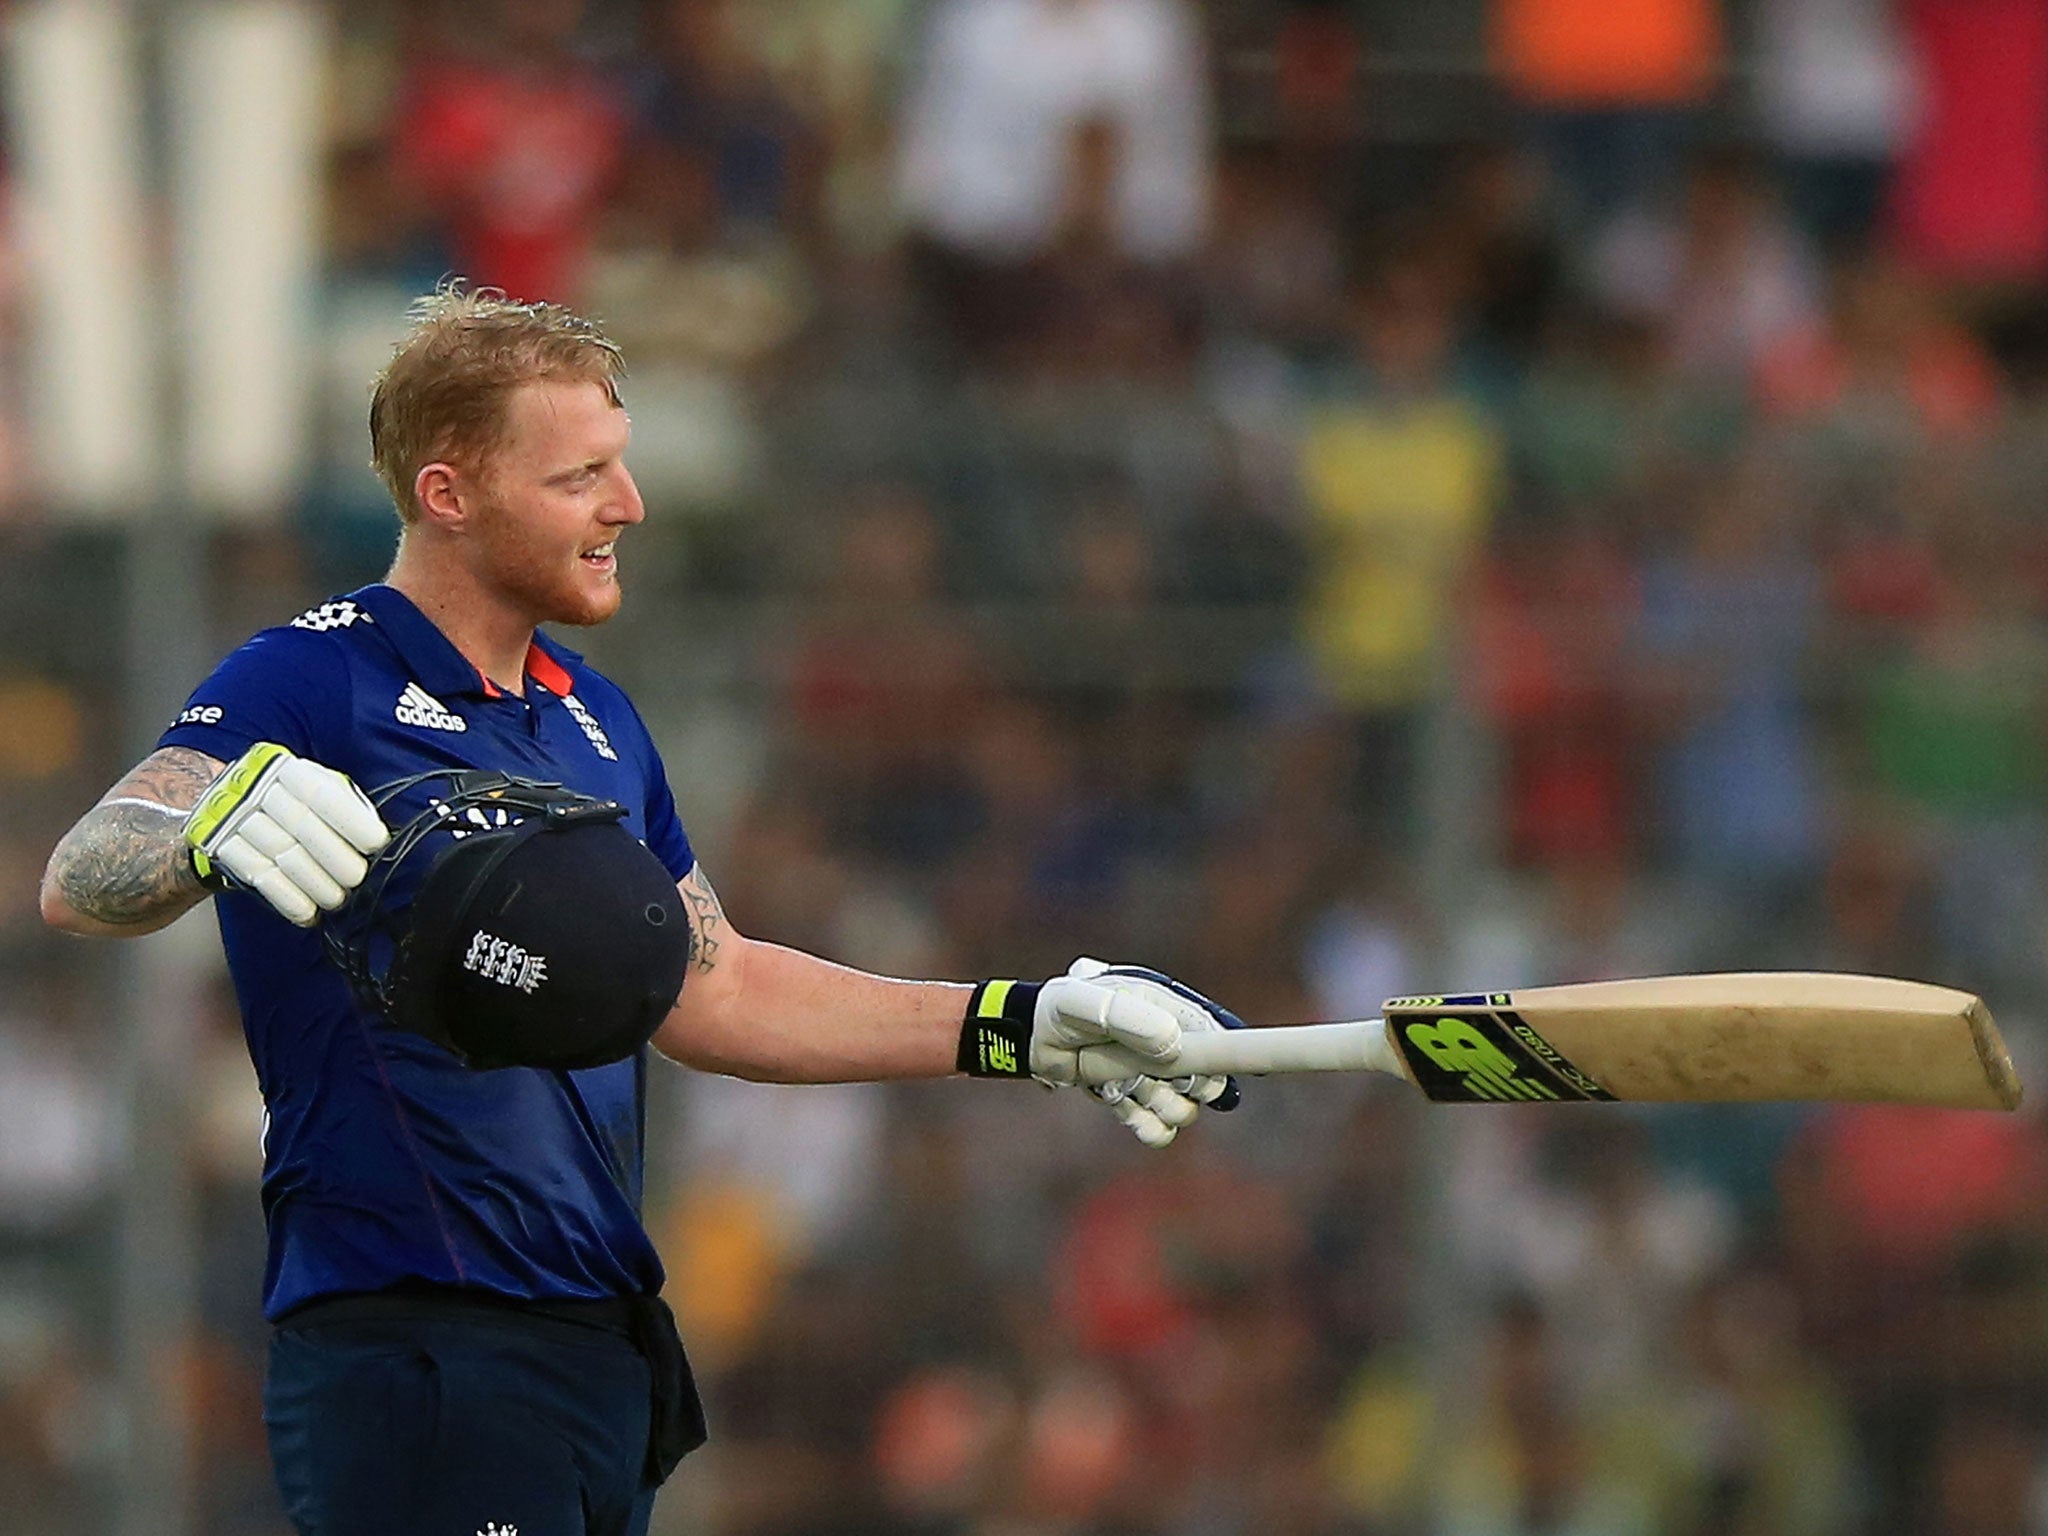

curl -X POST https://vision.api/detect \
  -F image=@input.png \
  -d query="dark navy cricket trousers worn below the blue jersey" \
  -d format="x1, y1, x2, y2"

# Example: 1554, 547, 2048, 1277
264, 1313, 655, 1536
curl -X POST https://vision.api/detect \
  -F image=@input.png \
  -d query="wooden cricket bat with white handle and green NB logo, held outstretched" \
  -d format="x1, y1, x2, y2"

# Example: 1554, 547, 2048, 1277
1081, 971, 2019, 1110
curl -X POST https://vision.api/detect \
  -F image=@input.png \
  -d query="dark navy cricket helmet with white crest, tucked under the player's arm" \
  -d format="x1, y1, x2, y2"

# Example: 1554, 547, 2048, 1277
322, 770, 690, 1069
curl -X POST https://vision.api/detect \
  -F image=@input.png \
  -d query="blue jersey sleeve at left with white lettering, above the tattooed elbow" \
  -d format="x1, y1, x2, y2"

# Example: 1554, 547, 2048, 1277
156, 627, 348, 762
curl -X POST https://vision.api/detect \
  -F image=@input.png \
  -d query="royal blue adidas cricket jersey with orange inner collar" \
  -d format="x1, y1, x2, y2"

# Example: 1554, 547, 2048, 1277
160, 586, 692, 1319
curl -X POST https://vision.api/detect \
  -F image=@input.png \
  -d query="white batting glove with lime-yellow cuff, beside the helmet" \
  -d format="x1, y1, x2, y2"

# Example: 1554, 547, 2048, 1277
184, 741, 391, 928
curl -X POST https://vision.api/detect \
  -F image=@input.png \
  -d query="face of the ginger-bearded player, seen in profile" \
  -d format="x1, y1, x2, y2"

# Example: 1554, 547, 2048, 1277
471, 381, 645, 627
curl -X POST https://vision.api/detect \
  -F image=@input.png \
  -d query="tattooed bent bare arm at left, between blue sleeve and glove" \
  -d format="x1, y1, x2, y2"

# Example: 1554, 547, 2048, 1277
49, 748, 221, 926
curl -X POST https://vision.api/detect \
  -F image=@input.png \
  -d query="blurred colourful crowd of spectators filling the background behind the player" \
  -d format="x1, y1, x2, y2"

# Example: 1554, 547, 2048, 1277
0, 0, 2048, 1536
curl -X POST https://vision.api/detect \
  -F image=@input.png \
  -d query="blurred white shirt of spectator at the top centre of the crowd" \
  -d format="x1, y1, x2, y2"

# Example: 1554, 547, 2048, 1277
899, 0, 1210, 262
